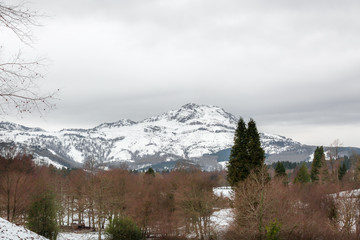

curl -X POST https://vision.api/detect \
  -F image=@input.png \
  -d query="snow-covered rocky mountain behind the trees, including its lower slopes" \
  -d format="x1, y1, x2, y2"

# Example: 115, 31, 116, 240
0, 103, 358, 170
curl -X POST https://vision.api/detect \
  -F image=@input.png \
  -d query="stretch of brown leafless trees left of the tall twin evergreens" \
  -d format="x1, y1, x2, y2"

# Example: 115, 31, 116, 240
0, 156, 228, 239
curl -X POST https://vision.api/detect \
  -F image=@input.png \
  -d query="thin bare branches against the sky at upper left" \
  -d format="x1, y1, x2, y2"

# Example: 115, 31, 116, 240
0, 2, 55, 114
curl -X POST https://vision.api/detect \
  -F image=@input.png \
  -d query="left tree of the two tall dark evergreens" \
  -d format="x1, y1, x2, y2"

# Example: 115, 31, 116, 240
227, 118, 250, 186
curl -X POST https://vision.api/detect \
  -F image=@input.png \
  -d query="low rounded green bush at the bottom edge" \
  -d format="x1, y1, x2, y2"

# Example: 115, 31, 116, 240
105, 217, 144, 240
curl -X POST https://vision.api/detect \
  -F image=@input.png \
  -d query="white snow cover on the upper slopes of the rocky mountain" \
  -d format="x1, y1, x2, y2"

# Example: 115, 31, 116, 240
0, 104, 297, 166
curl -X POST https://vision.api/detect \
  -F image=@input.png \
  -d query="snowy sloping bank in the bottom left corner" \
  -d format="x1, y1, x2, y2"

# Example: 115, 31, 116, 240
0, 218, 47, 240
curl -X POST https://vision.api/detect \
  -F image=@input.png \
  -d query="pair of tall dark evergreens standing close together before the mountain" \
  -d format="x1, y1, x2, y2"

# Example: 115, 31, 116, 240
228, 118, 265, 186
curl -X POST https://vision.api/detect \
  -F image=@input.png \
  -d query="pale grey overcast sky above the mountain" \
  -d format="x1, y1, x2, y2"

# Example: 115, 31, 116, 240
2, 0, 360, 147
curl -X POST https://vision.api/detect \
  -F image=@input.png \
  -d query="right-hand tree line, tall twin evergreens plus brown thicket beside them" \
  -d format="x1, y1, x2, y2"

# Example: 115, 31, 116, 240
228, 118, 360, 240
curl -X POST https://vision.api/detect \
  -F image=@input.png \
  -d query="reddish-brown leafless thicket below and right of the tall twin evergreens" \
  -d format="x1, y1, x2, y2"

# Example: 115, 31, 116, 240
226, 172, 359, 239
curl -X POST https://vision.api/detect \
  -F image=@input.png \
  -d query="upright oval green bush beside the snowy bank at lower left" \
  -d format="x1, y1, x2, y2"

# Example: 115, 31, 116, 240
27, 190, 59, 240
